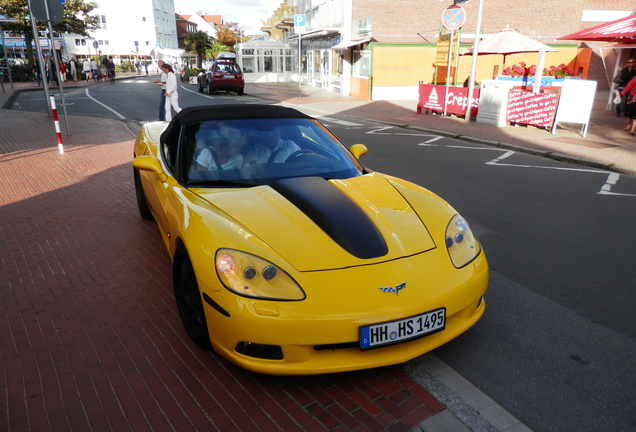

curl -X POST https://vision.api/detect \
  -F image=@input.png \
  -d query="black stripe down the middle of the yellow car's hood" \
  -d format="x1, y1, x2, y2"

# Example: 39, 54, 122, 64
271, 177, 389, 259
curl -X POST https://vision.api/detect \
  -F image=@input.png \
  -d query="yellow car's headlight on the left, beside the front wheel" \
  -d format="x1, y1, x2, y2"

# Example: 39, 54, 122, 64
215, 249, 305, 300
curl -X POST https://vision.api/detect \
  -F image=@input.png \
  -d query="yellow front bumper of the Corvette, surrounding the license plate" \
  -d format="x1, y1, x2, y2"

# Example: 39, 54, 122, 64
199, 251, 488, 375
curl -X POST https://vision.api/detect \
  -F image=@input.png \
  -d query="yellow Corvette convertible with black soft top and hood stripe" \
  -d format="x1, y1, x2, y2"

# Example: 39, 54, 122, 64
133, 105, 488, 375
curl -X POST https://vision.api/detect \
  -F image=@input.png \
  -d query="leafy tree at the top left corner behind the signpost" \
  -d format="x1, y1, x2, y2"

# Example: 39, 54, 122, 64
0, 0, 99, 64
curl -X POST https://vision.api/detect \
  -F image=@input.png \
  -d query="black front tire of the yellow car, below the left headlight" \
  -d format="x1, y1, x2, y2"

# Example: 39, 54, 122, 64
173, 246, 212, 348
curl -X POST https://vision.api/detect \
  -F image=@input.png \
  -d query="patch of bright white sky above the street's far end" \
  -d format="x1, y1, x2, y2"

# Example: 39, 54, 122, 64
174, 0, 284, 35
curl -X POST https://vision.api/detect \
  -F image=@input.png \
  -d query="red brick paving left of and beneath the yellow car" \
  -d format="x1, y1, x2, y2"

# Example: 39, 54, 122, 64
0, 94, 444, 432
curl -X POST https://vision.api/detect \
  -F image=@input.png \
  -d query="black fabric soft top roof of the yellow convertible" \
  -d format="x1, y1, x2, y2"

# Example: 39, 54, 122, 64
160, 104, 311, 142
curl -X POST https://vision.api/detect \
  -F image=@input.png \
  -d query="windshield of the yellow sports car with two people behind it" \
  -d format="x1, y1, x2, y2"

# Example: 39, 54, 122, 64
181, 118, 362, 187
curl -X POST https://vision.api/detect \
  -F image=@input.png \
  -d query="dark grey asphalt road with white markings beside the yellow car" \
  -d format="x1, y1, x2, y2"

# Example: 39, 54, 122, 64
9, 77, 636, 431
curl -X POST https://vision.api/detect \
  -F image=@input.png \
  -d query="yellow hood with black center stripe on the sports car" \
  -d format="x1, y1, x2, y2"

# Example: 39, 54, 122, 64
197, 173, 435, 271
